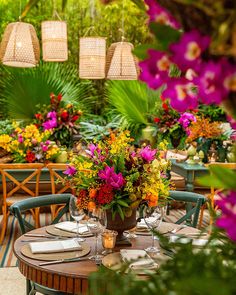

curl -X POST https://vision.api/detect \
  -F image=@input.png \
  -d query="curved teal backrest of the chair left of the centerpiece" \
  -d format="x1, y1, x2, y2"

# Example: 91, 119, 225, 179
10, 194, 72, 234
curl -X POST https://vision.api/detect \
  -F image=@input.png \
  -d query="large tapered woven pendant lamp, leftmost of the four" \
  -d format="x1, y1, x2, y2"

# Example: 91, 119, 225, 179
0, 22, 40, 68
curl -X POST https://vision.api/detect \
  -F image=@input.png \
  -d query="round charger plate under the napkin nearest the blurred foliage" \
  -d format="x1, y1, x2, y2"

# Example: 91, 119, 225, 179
102, 252, 159, 275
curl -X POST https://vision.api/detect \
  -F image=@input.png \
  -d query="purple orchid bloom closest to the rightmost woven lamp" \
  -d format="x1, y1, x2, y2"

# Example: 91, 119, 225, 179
139, 49, 171, 89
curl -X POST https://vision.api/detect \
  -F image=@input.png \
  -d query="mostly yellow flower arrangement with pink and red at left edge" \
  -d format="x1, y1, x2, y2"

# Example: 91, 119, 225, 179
0, 124, 59, 163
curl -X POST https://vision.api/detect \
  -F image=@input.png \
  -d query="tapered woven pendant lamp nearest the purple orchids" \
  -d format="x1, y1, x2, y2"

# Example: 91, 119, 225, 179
106, 41, 139, 80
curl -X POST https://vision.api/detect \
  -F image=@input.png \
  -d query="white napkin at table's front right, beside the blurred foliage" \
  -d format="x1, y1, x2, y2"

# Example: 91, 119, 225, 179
120, 249, 158, 269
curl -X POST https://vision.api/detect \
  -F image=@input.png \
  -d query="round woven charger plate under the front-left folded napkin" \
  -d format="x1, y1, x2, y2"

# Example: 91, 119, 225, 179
21, 243, 90, 261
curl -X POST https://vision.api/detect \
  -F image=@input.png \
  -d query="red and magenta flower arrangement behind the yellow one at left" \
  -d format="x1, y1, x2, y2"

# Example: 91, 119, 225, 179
35, 93, 82, 147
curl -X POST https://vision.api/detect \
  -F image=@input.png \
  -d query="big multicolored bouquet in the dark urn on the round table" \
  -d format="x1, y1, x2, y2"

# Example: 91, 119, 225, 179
65, 131, 169, 220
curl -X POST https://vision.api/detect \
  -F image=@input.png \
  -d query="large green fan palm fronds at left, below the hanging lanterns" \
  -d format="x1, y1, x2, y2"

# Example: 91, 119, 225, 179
0, 63, 92, 119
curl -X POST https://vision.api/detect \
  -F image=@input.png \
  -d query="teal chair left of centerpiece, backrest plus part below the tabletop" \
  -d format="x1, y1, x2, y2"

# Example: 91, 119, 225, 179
10, 194, 72, 295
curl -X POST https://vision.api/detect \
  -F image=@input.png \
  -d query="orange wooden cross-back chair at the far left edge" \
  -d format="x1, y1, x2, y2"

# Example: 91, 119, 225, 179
0, 163, 44, 244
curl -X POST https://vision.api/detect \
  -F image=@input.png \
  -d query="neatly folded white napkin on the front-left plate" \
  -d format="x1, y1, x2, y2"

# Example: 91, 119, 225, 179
29, 239, 82, 254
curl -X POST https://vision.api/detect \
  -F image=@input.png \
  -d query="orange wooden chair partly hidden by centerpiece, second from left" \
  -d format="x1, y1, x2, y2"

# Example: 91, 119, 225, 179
47, 163, 72, 219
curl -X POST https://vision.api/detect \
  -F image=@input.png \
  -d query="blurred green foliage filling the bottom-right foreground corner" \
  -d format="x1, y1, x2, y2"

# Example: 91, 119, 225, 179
90, 231, 236, 295
